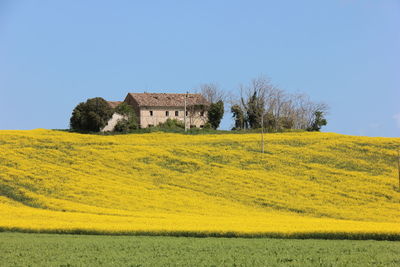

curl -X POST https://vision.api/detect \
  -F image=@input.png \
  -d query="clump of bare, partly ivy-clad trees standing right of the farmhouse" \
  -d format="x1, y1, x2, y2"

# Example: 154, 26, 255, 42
231, 76, 328, 131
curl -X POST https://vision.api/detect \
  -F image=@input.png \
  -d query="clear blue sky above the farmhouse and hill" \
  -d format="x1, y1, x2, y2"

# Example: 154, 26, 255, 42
0, 0, 400, 137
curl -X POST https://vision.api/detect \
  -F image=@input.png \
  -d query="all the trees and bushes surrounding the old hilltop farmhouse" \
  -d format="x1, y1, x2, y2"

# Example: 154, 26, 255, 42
70, 76, 328, 132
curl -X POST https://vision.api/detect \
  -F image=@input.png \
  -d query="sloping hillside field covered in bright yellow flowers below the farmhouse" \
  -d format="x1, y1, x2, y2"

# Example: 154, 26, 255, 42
0, 130, 400, 239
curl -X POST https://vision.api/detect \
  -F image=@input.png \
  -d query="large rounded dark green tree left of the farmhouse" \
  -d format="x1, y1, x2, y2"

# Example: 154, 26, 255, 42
70, 97, 113, 132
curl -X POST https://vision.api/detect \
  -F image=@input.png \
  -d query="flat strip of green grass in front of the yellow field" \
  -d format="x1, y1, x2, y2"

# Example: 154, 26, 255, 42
0, 233, 400, 266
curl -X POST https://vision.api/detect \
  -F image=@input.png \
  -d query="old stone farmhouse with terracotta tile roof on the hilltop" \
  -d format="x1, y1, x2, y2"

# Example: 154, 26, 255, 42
102, 93, 209, 131
